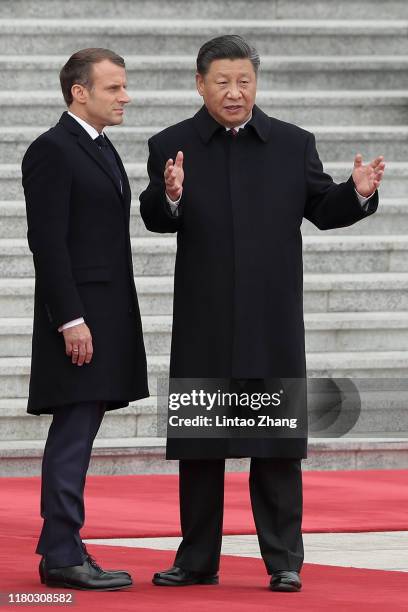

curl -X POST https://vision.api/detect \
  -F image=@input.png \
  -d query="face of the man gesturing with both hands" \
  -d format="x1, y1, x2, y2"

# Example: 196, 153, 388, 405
196, 59, 256, 127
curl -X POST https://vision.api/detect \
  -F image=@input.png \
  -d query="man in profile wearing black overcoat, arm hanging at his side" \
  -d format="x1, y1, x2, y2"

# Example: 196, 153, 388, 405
22, 49, 149, 590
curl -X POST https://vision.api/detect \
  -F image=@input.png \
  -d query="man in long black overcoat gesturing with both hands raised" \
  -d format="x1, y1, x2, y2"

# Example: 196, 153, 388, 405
140, 36, 384, 591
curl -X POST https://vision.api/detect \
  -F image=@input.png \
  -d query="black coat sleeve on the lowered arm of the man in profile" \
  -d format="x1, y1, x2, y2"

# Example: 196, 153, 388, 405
22, 138, 85, 329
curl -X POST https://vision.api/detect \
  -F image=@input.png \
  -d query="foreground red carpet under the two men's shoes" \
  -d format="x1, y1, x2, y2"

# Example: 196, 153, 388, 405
0, 537, 408, 612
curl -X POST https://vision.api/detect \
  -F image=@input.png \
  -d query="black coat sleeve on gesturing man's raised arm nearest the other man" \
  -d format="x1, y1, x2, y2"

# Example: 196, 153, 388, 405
140, 138, 183, 233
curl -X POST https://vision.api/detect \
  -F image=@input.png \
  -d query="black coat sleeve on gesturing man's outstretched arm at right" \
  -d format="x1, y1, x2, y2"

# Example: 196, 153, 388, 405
303, 134, 378, 230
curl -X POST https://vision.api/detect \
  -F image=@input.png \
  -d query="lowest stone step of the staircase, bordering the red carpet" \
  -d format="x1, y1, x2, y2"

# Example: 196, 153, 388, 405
0, 436, 408, 477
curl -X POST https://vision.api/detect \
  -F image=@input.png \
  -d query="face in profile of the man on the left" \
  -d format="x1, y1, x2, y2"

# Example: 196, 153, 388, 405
74, 60, 130, 132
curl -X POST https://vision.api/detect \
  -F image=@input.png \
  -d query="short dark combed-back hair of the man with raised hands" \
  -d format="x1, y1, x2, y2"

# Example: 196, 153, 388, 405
197, 34, 261, 76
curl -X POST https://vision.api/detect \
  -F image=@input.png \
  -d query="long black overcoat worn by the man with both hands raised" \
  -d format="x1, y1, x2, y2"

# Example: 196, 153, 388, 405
140, 106, 378, 458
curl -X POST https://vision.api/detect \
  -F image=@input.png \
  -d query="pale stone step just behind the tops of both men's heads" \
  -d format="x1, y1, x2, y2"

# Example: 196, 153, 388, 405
0, 20, 408, 56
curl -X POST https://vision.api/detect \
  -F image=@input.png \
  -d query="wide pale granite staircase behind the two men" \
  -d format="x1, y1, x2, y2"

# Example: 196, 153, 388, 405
0, 0, 408, 475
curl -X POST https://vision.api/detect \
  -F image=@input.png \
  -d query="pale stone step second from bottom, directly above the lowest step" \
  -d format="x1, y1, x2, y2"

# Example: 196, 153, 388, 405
0, 381, 408, 443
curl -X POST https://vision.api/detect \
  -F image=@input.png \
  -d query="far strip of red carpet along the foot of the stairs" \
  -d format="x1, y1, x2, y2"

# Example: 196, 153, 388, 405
0, 470, 408, 538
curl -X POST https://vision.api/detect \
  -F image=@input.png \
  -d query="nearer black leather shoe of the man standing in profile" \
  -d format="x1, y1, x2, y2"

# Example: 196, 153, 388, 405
39, 555, 133, 591
